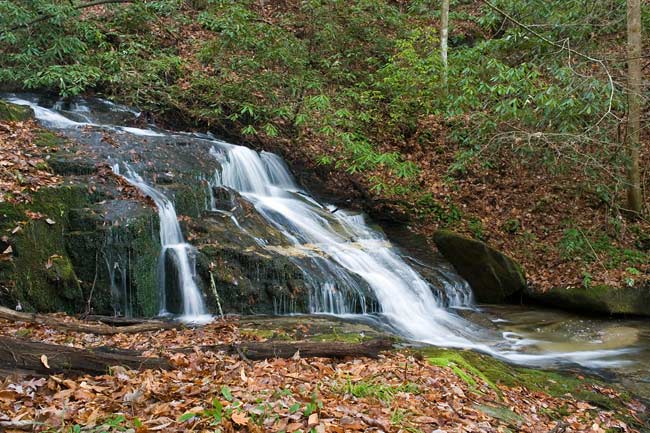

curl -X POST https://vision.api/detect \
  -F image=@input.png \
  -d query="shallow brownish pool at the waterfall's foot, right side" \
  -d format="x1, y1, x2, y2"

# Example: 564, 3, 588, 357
480, 305, 650, 400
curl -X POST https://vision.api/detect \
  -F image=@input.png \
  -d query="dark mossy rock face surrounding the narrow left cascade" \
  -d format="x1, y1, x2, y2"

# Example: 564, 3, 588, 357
0, 97, 309, 316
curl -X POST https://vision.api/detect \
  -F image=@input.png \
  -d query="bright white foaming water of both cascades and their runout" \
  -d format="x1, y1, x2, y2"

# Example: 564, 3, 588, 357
3, 94, 629, 367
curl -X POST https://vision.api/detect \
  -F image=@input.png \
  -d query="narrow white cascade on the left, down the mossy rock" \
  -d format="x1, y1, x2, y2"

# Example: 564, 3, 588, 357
113, 163, 210, 322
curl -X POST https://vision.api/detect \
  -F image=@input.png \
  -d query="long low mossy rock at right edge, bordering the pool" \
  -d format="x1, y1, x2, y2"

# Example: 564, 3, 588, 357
526, 285, 650, 316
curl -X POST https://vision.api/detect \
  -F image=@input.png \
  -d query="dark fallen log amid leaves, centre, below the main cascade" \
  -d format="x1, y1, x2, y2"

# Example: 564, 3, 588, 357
187, 338, 393, 360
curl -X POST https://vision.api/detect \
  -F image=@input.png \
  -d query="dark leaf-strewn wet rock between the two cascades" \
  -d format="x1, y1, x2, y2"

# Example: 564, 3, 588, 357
184, 207, 309, 314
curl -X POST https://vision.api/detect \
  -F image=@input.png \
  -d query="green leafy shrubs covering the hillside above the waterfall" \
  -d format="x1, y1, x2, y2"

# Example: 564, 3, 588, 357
0, 0, 636, 222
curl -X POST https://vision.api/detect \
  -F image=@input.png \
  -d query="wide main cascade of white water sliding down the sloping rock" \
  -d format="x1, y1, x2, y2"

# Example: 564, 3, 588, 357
211, 142, 472, 345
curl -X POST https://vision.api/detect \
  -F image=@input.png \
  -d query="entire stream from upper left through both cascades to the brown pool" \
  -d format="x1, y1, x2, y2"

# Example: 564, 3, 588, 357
5, 95, 650, 396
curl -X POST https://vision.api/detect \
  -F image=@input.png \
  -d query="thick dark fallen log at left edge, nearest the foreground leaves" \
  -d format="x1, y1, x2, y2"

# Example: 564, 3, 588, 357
0, 336, 171, 375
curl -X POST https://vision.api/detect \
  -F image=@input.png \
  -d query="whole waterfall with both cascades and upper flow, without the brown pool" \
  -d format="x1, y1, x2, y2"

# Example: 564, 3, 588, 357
6, 95, 630, 368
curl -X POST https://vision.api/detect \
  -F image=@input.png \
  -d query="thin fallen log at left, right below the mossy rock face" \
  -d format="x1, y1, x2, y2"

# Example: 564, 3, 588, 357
0, 307, 183, 335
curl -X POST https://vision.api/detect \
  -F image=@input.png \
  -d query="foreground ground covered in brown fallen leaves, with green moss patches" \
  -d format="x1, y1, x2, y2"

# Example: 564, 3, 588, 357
0, 315, 645, 433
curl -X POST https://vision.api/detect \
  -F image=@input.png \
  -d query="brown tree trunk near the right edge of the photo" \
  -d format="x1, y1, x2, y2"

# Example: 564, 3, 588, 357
627, 0, 642, 214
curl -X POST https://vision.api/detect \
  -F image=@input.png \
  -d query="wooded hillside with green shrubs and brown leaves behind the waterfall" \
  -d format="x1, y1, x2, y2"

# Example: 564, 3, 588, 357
0, 0, 650, 290
